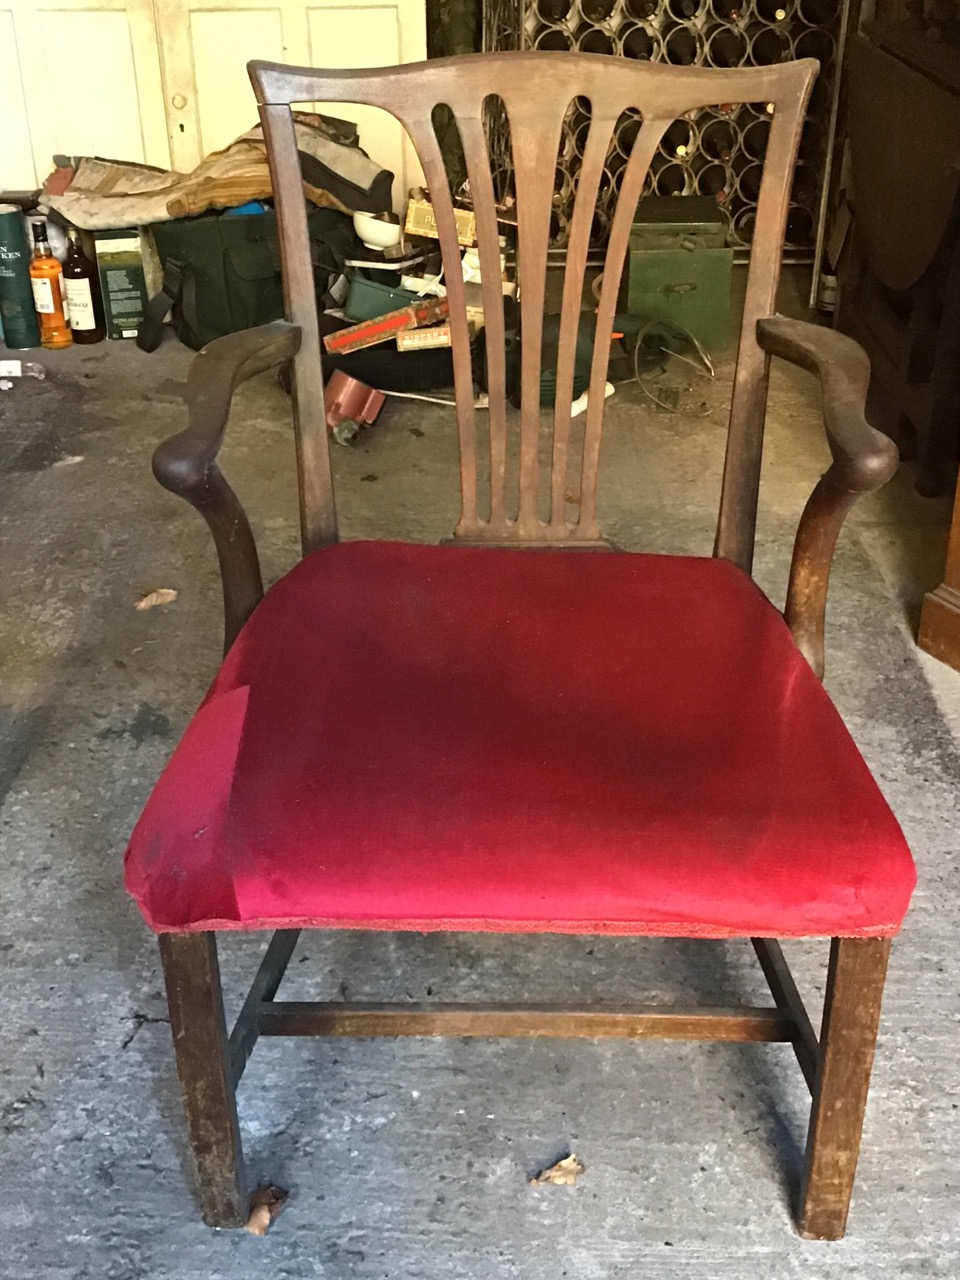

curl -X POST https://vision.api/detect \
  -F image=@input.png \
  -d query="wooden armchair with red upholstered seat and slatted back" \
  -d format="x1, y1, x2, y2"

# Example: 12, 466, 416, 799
127, 52, 915, 1239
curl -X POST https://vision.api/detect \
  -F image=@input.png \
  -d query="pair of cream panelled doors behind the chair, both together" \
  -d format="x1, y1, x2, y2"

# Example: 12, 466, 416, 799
0, 0, 426, 201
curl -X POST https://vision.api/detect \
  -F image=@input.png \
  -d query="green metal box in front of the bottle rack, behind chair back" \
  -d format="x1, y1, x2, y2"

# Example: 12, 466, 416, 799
620, 196, 733, 351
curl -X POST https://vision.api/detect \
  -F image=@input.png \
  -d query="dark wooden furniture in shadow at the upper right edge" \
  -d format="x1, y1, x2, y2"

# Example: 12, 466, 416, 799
837, 22, 960, 497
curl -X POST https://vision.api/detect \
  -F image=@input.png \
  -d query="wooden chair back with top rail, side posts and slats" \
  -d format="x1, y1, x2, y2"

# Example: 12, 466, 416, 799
250, 52, 817, 555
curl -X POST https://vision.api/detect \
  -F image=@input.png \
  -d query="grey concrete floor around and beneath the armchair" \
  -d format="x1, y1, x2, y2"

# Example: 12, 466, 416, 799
0, 272, 960, 1280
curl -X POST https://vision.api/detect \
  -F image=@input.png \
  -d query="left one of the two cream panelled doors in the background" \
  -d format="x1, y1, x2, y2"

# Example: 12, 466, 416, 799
0, 0, 170, 191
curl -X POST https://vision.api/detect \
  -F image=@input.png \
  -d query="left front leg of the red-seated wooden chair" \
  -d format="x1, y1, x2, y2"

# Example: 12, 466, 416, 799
159, 933, 250, 1226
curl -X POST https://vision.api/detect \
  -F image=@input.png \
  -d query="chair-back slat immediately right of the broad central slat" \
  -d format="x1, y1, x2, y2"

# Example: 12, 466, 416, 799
550, 111, 616, 538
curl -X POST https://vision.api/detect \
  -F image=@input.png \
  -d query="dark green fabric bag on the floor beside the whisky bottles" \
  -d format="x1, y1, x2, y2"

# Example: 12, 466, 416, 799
137, 207, 360, 351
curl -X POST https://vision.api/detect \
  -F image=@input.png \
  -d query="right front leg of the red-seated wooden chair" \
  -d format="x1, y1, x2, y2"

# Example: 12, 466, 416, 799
797, 938, 890, 1240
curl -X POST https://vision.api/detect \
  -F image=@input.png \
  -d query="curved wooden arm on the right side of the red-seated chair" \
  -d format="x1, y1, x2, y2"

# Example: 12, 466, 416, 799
756, 316, 899, 677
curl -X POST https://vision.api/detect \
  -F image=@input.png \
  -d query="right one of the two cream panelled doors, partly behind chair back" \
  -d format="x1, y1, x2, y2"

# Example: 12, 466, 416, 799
156, 0, 426, 206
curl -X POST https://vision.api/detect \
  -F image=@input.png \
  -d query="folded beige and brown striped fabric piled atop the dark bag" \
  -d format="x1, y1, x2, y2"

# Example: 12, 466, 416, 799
44, 111, 393, 230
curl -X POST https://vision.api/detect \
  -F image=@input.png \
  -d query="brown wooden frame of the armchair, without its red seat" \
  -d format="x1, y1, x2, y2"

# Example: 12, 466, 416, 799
154, 52, 897, 1239
